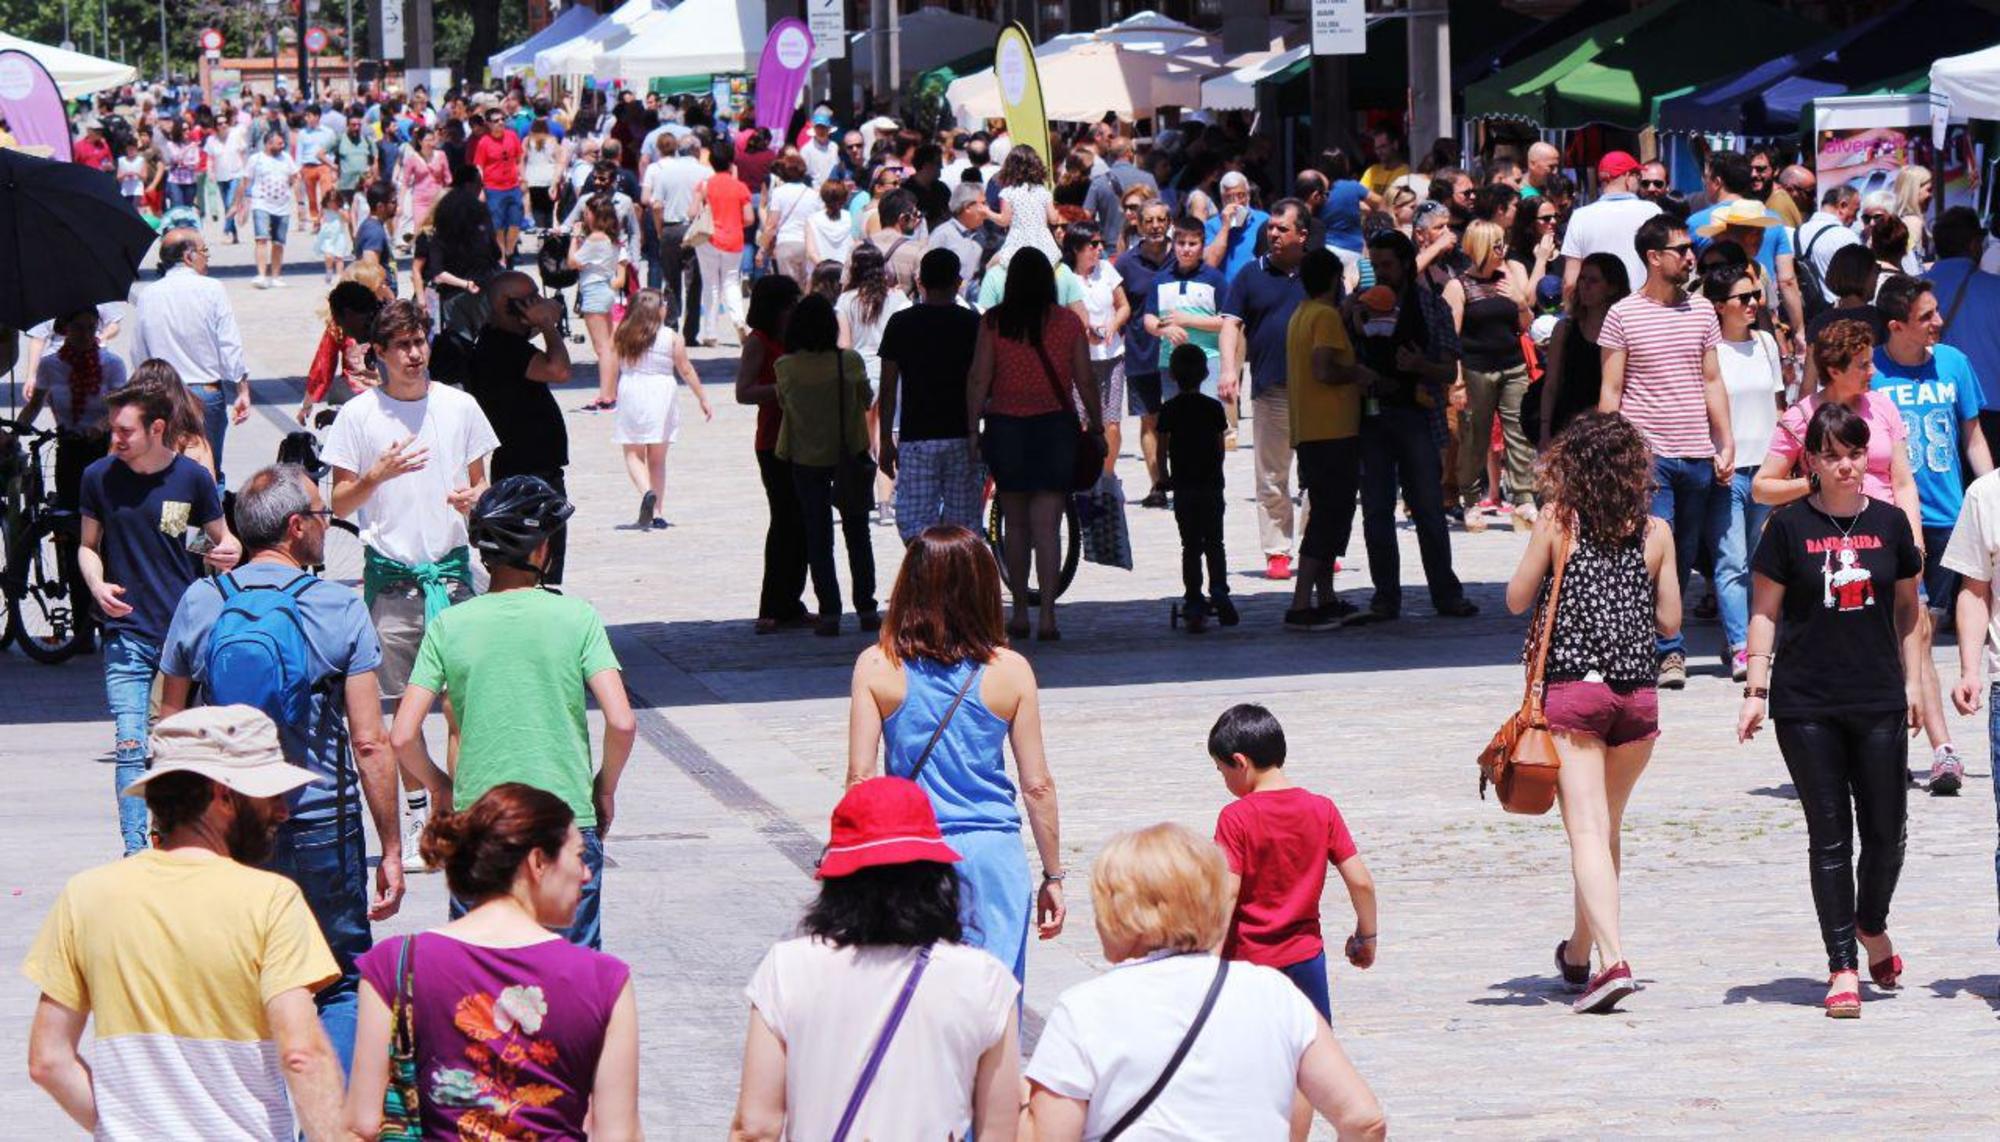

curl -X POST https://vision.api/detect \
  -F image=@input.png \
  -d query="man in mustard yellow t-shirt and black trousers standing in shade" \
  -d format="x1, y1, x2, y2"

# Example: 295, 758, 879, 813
1284, 248, 1374, 630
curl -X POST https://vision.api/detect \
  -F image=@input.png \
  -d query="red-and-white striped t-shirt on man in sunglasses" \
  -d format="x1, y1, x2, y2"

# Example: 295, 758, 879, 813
1598, 294, 1722, 460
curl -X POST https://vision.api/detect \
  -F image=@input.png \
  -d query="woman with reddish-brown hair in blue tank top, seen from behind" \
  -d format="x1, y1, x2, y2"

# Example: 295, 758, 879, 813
848, 526, 1064, 980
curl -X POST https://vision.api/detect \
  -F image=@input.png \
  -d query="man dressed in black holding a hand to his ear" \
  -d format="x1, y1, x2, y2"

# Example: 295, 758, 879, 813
466, 270, 570, 584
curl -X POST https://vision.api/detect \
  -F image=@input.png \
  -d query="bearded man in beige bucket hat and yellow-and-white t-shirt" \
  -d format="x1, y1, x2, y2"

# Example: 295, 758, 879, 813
22, 706, 342, 1142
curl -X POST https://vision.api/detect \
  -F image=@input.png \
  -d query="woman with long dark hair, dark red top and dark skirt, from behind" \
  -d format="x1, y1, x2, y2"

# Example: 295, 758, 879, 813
966, 252, 1104, 642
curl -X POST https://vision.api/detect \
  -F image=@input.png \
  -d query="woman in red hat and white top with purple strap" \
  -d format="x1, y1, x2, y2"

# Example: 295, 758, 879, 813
730, 778, 1024, 1140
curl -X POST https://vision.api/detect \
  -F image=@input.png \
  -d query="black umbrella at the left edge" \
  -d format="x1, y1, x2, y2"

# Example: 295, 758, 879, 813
0, 148, 158, 330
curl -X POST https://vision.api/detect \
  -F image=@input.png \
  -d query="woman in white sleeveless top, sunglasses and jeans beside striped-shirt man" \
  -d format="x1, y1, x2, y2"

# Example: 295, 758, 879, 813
1702, 266, 1784, 682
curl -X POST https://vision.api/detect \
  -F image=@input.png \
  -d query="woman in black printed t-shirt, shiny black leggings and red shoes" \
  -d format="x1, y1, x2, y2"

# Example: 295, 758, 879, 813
1736, 402, 1924, 1018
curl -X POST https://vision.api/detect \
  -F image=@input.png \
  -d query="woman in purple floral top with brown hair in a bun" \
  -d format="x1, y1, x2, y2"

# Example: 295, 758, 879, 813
346, 782, 640, 1140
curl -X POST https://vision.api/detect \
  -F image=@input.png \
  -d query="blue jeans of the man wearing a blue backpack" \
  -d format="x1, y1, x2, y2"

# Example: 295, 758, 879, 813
266, 816, 374, 1074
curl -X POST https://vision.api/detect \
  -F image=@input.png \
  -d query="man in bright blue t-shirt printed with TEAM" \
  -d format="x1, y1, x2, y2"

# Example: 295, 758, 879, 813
1872, 274, 1994, 794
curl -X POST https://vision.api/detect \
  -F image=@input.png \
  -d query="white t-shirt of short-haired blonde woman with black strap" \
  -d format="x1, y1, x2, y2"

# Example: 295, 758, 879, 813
1026, 956, 1320, 1142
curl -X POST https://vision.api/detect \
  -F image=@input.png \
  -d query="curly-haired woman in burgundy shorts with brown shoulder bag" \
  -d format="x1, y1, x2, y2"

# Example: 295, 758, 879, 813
1506, 412, 1680, 1014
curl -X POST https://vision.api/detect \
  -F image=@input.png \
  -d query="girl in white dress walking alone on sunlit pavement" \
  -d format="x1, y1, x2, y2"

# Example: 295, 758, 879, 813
612, 290, 716, 530
